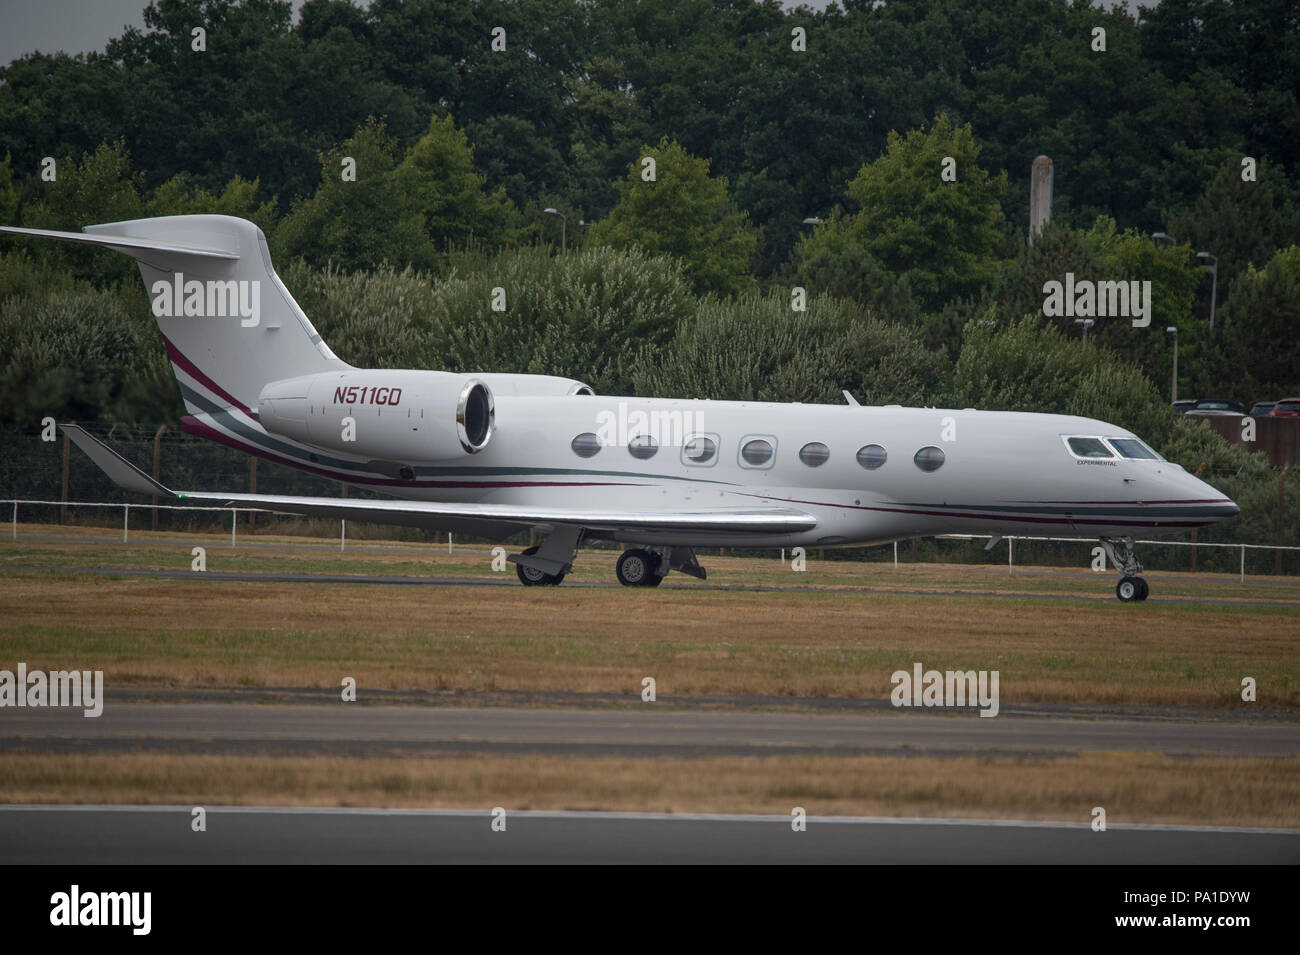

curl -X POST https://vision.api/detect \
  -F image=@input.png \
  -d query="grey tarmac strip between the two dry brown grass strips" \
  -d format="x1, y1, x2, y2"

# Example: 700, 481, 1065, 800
0, 699, 1300, 756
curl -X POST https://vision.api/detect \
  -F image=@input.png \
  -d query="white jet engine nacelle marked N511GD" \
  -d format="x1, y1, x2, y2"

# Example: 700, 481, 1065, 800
257, 369, 497, 469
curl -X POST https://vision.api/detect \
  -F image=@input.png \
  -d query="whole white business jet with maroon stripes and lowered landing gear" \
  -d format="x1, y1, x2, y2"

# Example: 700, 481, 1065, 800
0, 216, 1238, 600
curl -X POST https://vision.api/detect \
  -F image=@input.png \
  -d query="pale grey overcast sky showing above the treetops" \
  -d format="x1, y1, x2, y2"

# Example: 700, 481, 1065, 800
0, 0, 1156, 70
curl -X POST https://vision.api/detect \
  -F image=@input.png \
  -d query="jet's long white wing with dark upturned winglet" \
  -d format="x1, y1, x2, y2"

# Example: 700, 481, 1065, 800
62, 425, 816, 537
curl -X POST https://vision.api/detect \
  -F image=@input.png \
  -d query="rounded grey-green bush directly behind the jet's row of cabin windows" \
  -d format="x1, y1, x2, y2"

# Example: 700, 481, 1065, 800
634, 292, 945, 404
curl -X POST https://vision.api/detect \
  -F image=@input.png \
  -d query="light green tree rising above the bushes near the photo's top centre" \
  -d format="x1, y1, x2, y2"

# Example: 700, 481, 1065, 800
589, 138, 758, 295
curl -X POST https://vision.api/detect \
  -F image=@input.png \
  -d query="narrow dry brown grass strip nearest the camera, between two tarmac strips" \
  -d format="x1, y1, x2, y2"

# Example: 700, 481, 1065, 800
0, 752, 1300, 828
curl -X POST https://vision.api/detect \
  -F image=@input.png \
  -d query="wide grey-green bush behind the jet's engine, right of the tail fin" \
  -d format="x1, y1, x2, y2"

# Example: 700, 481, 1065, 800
283, 247, 694, 394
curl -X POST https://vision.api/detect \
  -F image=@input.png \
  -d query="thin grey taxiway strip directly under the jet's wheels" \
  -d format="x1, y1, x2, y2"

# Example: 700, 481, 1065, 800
0, 564, 1300, 611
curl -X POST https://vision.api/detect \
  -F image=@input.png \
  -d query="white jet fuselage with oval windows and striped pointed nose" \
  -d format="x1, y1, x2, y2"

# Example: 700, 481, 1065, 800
180, 395, 1238, 546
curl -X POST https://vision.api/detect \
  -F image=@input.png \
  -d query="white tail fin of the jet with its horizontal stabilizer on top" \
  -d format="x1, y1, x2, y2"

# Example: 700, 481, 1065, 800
0, 216, 348, 414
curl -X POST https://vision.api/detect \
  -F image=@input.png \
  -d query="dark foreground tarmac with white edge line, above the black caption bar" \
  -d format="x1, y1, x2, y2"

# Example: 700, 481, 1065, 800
0, 806, 1300, 865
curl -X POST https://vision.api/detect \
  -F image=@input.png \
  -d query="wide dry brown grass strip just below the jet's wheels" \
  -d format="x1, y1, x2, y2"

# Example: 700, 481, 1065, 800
0, 563, 1300, 707
